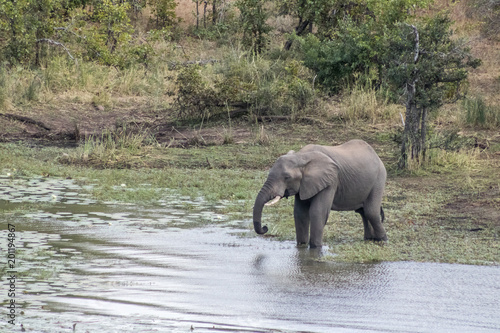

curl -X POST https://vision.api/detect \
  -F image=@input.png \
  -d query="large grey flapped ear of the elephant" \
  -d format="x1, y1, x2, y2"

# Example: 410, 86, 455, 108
299, 151, 338, 200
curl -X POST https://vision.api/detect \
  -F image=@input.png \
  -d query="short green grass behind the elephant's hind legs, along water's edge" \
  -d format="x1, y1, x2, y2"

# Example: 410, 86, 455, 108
326, 174, 500, 264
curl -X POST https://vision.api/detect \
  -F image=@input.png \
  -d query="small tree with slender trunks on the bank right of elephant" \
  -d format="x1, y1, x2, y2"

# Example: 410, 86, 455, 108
384, 15, 480, 169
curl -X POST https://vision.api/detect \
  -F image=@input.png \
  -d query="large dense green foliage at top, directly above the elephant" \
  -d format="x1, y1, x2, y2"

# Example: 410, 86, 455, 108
298, 0, 430, 92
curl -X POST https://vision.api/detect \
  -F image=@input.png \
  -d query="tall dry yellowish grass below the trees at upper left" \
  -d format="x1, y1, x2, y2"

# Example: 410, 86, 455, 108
0, 53, 181, 113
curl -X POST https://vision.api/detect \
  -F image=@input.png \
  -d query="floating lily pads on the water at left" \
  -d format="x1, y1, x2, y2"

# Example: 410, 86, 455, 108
0, 174, 229, 226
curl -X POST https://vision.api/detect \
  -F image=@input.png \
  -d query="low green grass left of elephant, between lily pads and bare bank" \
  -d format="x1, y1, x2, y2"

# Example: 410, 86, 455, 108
0, 140, 274, 203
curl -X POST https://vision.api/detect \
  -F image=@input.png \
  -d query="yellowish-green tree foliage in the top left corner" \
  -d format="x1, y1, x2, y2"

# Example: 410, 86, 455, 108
0, 0, 156, 67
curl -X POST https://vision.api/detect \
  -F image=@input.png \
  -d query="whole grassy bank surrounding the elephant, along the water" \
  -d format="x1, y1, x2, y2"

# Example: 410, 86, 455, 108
0, 123, 500, 264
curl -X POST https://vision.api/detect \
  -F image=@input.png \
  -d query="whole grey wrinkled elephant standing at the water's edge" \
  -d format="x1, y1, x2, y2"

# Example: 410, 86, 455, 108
253, 140, 387, 248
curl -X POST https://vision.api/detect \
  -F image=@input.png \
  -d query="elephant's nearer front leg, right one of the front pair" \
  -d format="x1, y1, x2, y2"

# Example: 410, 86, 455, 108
309, 188, 335, 248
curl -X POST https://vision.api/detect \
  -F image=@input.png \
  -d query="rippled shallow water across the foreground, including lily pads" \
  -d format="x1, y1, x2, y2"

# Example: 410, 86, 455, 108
0, 177, 500, 332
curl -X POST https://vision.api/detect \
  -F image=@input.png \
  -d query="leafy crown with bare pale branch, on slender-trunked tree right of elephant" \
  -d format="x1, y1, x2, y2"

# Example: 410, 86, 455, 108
383, 16, 481, 108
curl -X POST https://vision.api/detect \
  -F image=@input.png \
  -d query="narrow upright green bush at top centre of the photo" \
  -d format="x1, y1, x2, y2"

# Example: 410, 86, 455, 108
236, 0, 271, 54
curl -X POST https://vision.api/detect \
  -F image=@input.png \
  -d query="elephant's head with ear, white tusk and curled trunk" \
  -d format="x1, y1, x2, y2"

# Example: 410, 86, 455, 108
253, 151, 338, 234
